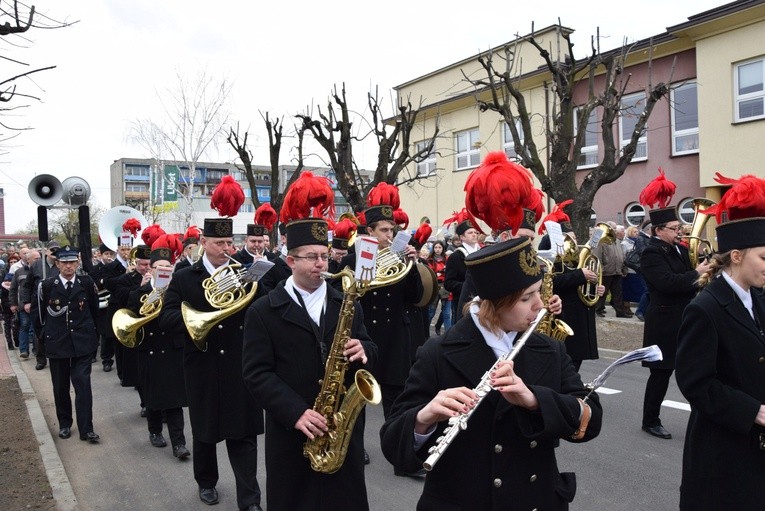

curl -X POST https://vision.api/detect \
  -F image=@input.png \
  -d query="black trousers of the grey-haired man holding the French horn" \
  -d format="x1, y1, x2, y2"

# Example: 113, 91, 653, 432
192, 436, 262, 509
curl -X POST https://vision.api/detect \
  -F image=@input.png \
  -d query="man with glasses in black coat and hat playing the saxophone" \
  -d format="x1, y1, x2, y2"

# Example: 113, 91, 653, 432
243, 219, 377, 511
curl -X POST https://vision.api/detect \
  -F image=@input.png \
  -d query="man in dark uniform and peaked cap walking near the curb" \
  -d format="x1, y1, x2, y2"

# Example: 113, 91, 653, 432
38, 246, 99, 443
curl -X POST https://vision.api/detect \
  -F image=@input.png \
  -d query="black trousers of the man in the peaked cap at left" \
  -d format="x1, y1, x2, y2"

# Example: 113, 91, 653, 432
49, 354, 93, 436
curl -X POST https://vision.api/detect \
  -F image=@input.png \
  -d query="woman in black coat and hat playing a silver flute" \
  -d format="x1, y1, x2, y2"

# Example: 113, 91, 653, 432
380, 238, 602, 511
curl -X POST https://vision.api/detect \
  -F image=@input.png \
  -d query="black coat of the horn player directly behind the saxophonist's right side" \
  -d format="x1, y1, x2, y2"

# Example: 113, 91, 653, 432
340, 253, 423, 385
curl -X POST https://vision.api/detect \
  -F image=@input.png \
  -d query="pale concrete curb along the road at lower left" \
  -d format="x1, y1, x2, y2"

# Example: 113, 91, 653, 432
8, 353, 79, 511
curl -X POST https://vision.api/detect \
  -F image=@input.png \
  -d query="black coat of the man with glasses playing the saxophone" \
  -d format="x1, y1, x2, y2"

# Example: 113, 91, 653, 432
243, 282, 377, 511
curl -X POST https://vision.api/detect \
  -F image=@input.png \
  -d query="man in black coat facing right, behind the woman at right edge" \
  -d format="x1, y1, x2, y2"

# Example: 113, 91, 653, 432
640, 207, 709, 439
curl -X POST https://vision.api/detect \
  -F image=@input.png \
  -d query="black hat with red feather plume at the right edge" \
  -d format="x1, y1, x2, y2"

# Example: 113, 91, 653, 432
702, 172, 765, 253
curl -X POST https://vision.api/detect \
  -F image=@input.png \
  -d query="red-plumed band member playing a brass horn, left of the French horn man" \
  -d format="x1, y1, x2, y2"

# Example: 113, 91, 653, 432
127, 234, 191, 460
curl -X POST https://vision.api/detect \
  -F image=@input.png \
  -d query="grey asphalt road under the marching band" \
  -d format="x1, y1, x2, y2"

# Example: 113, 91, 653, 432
19, 346, 688, 511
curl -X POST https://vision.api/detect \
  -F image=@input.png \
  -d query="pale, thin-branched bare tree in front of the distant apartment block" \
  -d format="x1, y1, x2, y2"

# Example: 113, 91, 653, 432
133, 72, 231, 226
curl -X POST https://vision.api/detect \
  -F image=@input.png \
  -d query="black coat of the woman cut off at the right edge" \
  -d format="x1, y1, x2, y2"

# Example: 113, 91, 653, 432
676, 277, 765, 511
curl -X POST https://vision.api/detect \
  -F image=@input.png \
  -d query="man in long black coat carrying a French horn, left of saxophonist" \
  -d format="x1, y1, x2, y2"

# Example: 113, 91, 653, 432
159, 218, 263, 510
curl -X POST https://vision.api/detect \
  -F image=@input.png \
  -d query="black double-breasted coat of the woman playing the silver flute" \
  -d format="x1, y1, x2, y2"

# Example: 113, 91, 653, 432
380, 316, 602, 511
